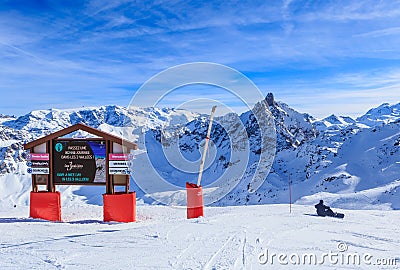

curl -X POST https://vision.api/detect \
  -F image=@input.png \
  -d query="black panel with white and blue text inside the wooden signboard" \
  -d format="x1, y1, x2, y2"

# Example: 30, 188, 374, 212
53, 140, 106, 185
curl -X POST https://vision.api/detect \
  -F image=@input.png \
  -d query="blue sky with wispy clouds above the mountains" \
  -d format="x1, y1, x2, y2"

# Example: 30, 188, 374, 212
0, 0, 400, 117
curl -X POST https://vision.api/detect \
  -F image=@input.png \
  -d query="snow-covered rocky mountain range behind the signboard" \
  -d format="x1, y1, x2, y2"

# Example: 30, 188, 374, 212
0, 94, 400, 209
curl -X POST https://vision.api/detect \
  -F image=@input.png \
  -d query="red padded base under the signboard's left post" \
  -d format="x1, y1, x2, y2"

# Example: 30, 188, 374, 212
29, 191, 61, 221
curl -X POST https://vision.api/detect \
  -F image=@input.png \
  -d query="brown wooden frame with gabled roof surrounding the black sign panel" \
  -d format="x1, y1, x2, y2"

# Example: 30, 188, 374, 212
24, 124, 137, 194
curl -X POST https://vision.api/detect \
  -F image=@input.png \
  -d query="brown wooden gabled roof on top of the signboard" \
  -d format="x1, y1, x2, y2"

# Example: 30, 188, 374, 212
24, 123, 137, 150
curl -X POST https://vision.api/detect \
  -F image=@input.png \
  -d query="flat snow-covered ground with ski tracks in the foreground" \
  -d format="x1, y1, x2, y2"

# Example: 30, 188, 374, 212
0, 204, 400, 269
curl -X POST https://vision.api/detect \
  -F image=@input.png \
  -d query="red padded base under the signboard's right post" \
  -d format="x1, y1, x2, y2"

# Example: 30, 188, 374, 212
103, 192, 136, 222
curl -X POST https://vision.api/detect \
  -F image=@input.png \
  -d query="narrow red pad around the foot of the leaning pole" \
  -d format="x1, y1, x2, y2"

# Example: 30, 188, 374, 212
186, 182, 204, 218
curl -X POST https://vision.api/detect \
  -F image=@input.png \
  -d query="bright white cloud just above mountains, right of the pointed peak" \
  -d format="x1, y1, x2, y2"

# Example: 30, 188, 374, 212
268, 70, 400, 118
